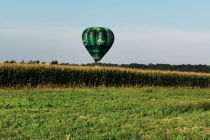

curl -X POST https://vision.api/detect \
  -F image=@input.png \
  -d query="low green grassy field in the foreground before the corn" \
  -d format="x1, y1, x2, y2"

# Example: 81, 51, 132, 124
0, 87, 210, 140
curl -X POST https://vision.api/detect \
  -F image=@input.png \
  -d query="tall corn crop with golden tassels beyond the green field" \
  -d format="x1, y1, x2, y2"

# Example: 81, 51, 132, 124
0, 64, 210, 88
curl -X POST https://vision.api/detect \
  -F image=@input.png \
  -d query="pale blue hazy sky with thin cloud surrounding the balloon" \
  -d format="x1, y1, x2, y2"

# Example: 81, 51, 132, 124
0, 0, 210, 65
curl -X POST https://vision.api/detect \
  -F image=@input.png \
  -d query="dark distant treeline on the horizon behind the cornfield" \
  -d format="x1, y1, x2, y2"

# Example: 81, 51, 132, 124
4, 60, 210, 73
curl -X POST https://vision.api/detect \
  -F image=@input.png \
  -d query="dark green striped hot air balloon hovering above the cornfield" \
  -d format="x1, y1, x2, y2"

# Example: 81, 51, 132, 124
82, 27, 114, 63
